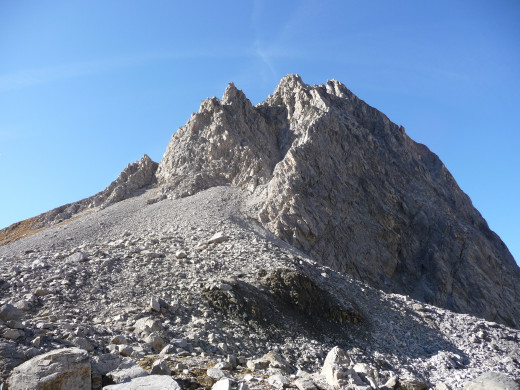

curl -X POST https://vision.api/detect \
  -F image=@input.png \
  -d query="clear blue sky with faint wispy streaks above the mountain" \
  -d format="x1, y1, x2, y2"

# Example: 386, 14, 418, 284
0, 0, 520, 261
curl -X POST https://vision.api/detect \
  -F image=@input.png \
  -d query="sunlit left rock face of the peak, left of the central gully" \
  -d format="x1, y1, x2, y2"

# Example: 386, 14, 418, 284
157, 84, 284, 196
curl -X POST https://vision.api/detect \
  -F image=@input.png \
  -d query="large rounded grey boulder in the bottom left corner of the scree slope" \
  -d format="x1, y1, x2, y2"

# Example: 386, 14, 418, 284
8, 348, 91, 390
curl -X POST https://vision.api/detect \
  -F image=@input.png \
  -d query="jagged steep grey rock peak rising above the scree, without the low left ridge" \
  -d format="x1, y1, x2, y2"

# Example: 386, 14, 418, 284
157, 75, 520, 327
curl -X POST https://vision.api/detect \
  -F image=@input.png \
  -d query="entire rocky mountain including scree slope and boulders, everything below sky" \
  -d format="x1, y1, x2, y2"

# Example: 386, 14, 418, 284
0, 75, 520, 390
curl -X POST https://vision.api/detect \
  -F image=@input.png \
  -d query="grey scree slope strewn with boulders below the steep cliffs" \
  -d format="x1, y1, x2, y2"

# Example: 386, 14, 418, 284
0, 186, 520, 390
